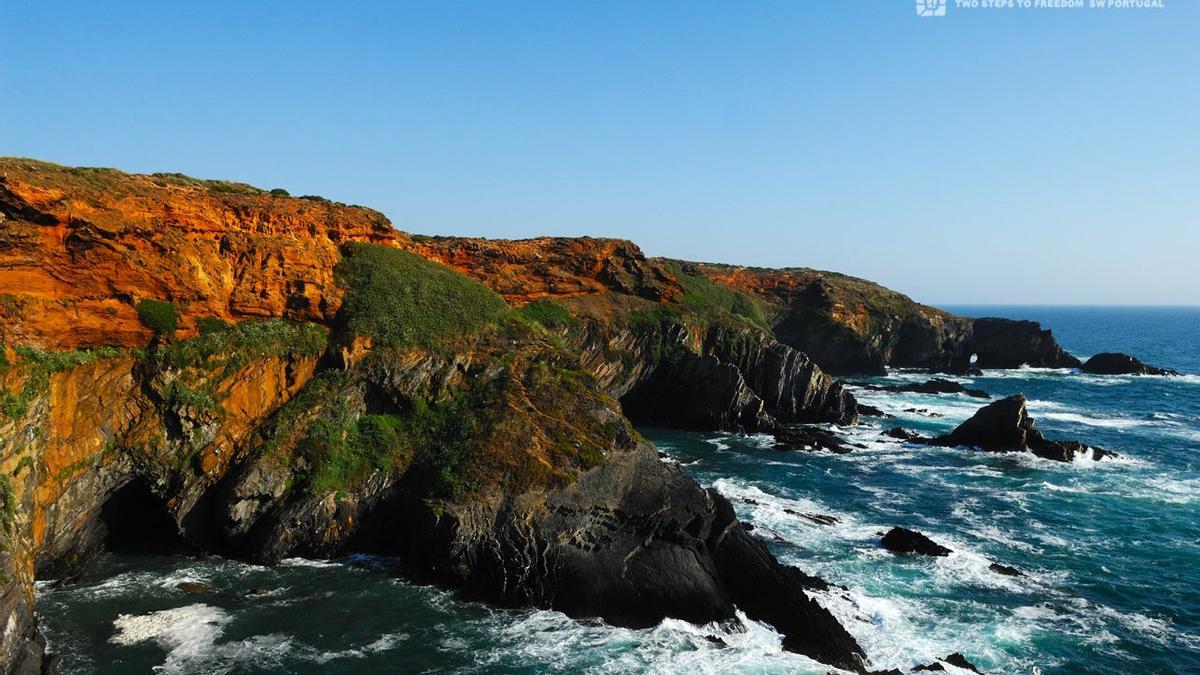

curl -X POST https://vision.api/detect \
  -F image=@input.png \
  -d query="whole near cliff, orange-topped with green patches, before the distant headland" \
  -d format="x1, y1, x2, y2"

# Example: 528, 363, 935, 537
0, 160, 865, 671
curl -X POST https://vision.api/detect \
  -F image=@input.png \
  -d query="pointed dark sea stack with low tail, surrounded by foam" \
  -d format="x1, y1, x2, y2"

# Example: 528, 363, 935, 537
925, 394, 1115, 461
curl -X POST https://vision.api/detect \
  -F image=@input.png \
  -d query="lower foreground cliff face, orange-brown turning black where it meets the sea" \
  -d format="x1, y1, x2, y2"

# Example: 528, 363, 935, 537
2, 327, 863, 669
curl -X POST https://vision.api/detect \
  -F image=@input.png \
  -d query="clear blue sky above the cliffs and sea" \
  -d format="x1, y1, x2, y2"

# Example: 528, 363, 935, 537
0, 0, 1200, 304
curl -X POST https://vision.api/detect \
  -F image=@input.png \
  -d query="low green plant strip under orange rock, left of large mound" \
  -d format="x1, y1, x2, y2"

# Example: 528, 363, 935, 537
158, 317, 328, 371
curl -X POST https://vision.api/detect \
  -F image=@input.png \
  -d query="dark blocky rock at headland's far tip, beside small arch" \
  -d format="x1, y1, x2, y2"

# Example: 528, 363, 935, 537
972, 317, 1080, 368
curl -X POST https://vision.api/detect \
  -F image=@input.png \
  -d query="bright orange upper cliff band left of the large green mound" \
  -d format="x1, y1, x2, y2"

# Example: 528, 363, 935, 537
0, 159, 401, 350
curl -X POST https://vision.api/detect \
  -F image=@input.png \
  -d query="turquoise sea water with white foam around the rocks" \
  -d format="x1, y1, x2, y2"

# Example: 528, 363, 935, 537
40, 307, 1200, 673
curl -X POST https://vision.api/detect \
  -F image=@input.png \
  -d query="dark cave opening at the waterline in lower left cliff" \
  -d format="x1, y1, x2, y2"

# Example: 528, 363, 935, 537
100, 479, 190, 554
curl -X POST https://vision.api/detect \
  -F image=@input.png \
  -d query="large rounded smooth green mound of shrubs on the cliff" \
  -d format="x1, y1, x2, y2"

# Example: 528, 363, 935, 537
336, 244, 509, 348
